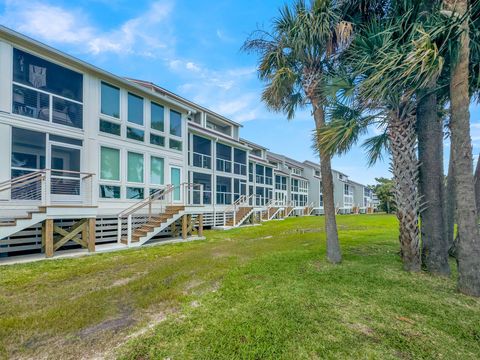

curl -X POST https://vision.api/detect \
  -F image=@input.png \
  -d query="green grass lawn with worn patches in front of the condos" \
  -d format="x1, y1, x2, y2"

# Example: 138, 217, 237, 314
0, 215, 480, 359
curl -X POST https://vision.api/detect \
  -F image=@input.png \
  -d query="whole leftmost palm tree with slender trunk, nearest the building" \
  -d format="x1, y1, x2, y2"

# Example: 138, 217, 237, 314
243, 0, 351, 263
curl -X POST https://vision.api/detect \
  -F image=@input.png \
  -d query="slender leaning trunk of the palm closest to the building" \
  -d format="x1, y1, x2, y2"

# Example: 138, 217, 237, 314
312, 99, 342, 264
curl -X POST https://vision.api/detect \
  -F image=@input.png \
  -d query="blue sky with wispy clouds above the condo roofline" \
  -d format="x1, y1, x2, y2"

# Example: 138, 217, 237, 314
0, 0, 480, 184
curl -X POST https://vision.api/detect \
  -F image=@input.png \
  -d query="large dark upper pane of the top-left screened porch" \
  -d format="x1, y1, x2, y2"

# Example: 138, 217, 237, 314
13, 49, 83, 102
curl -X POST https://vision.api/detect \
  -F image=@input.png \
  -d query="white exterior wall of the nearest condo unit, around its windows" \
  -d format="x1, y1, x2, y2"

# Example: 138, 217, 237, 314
0, 36, 191, 214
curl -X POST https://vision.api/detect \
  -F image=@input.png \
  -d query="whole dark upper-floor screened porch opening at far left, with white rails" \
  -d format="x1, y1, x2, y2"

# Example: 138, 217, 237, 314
12, 49, 83, 129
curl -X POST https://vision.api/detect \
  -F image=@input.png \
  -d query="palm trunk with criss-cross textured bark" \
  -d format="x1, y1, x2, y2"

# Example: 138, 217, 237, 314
388, 114, 420, 271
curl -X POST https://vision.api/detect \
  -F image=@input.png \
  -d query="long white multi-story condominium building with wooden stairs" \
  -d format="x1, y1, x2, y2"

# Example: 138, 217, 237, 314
0, 27, 371, 256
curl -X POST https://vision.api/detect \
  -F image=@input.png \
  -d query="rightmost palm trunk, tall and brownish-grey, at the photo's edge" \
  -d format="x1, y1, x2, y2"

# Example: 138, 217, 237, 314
444, 0, 480, 296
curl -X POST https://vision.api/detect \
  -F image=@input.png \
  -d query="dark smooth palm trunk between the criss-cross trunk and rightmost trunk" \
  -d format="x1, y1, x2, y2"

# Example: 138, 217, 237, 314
417, 86, 450, 276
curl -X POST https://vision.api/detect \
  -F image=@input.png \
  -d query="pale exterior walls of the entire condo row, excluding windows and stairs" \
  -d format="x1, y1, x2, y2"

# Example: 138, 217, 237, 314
0, 27, 376, 225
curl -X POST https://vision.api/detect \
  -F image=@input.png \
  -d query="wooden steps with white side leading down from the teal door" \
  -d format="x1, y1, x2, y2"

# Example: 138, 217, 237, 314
121, 205, 185, 244
